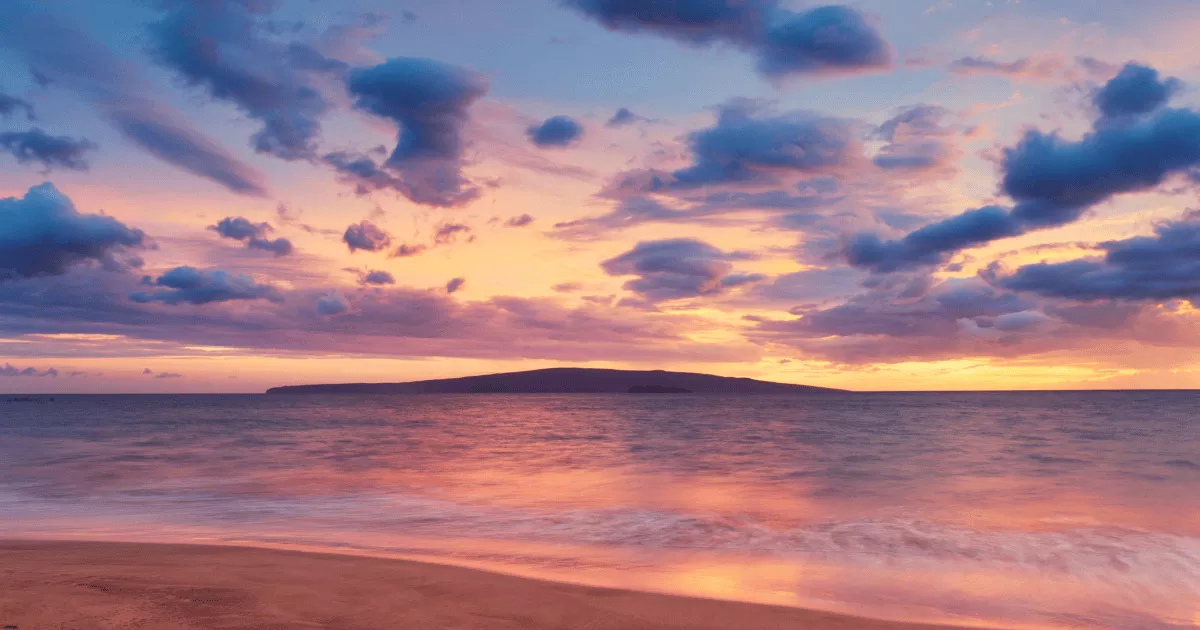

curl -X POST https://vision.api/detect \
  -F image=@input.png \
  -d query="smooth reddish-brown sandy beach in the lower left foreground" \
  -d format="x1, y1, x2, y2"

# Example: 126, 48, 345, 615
0, 541, 974, 630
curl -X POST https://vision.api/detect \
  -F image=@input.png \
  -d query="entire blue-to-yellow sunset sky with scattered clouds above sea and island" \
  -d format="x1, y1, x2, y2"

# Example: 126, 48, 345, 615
0, 0, 1200, 394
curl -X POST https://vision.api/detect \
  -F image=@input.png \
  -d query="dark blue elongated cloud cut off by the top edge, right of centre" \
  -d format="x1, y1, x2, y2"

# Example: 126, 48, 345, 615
564, 0, 892, 77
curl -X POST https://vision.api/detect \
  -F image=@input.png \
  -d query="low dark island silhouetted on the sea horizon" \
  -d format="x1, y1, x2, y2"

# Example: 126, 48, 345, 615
266, 367, 842, 394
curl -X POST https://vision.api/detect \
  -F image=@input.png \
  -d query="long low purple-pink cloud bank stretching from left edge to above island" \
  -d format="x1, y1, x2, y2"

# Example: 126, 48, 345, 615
0, 266, 761, 362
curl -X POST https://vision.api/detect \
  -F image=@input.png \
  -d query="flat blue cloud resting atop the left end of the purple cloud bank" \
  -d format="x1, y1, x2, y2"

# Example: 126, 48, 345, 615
130, 266, 282, 306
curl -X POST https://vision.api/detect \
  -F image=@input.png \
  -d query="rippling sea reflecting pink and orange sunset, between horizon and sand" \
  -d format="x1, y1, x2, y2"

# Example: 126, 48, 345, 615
0, 392, 1200, 629
